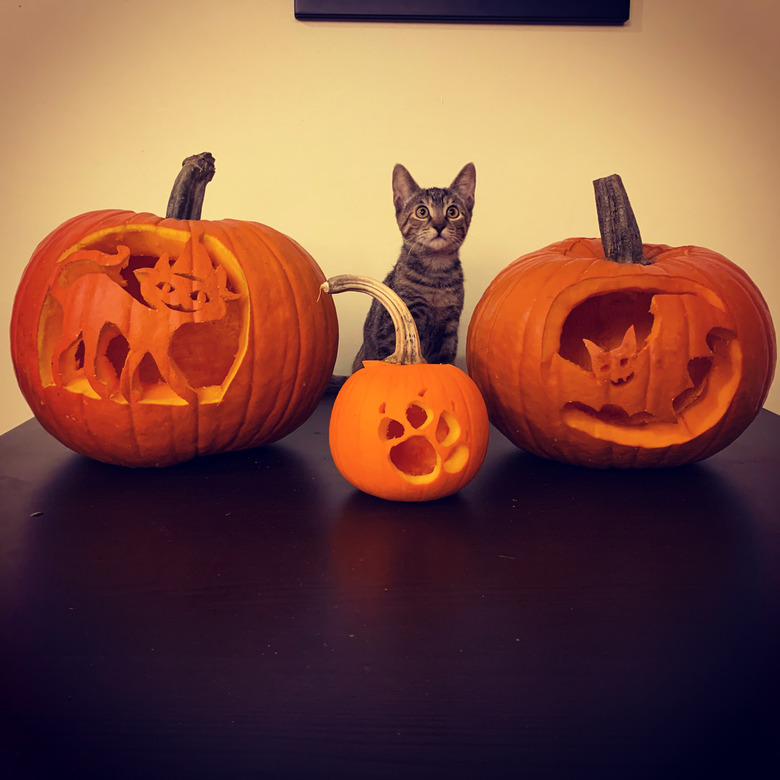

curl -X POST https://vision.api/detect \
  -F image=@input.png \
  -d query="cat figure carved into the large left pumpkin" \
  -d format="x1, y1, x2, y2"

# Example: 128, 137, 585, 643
51, 238, 241, 403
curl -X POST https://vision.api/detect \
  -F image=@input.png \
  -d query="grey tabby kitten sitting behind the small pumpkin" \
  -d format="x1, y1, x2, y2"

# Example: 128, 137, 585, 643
352, 163, 476, 372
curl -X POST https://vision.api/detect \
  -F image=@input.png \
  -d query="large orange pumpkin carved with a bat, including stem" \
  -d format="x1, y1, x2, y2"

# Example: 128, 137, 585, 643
466, 176, 776, 467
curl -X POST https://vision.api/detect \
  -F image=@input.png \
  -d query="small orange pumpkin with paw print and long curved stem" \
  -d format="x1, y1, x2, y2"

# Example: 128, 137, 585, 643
322, 275, 489, 501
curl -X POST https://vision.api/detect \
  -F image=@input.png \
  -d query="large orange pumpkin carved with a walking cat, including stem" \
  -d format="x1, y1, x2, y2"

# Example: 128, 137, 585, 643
11, 154, 338, 466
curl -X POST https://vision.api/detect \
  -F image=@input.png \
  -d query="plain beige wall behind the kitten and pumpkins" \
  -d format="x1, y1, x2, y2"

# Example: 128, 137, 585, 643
0, 0, 780, 431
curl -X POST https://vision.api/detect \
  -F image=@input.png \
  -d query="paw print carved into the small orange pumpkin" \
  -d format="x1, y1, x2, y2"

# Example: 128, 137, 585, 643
379, 393, 469, 484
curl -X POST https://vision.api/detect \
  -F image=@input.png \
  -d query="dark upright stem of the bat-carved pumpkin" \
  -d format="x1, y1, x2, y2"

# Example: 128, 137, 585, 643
593, 173, 650, 265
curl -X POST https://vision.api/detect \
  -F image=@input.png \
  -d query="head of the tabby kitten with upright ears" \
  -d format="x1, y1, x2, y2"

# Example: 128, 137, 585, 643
393, 163, 477, 254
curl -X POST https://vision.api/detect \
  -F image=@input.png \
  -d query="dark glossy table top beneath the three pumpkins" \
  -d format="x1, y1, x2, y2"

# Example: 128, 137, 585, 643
0, 400, 780, 780
